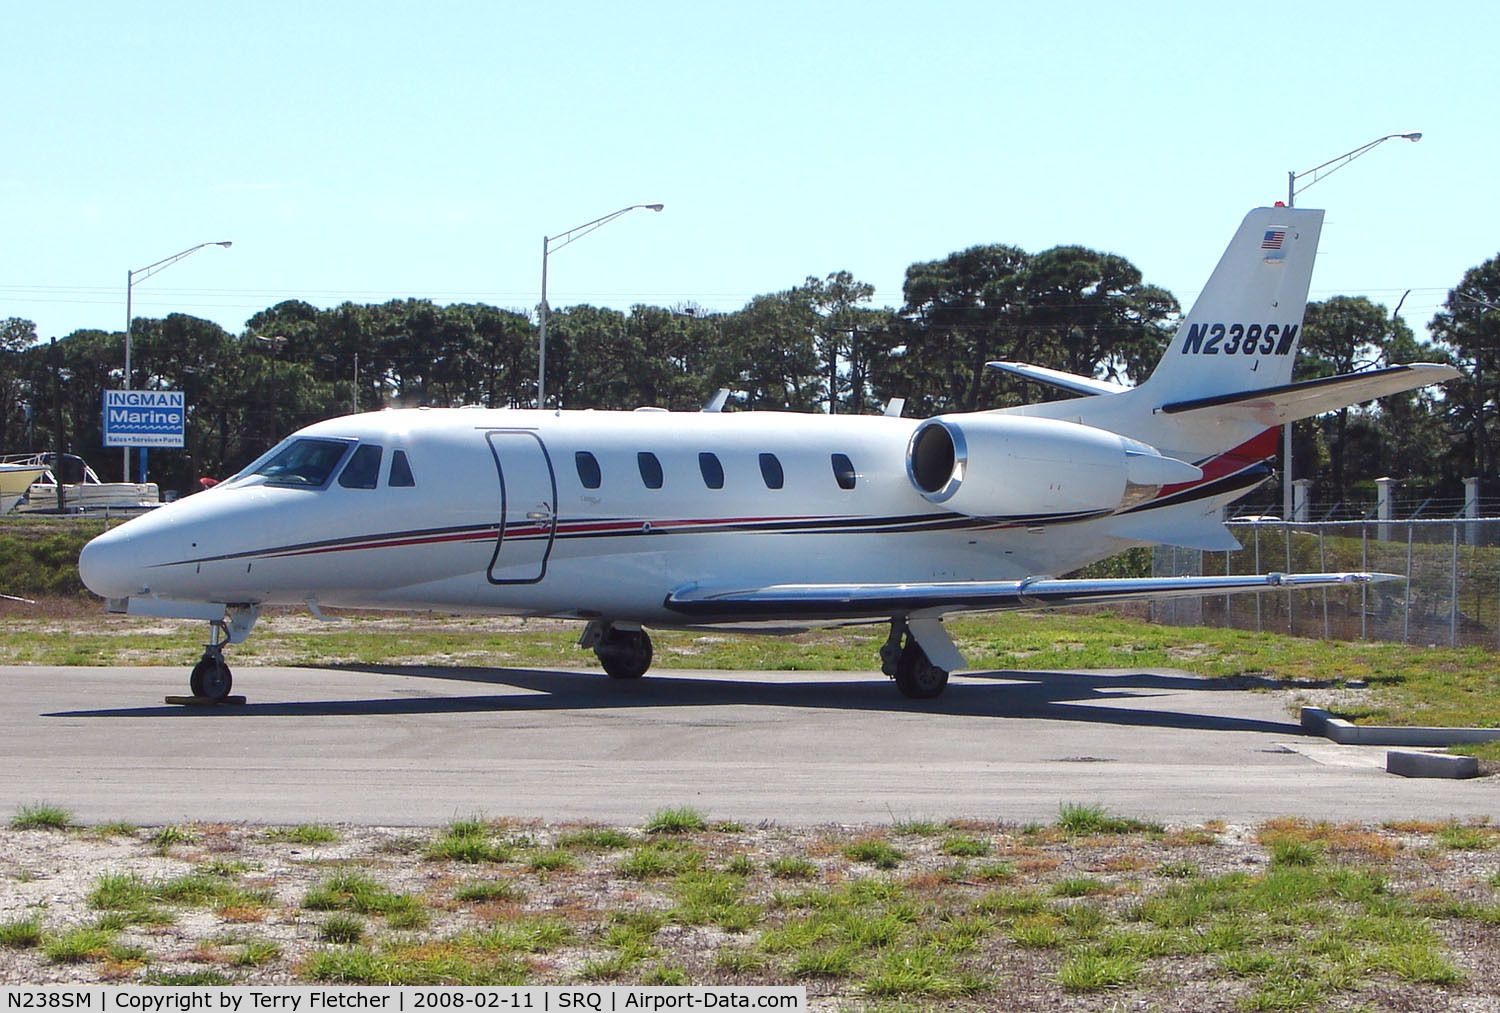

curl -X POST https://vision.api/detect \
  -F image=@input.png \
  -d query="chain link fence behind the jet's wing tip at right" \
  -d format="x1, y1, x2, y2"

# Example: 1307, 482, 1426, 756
1152, 518, 1500, 650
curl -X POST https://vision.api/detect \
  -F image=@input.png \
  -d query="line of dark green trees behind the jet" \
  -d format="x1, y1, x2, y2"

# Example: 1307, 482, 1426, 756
0, 245, 1500, 503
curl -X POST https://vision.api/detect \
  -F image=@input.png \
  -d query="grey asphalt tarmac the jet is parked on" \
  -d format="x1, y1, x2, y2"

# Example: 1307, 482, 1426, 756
0, 666, 1500, 825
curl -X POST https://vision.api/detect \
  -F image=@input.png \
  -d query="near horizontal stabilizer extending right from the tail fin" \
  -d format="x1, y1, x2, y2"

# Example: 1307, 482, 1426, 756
1161, 362, 1460, 426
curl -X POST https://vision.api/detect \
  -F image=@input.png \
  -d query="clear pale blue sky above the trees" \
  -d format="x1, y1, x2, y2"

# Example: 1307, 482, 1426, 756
0, 0, 1500, 345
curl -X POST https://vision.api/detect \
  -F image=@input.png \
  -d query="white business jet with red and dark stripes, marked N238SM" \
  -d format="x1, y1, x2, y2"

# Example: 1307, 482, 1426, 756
78, 207, 1457, 699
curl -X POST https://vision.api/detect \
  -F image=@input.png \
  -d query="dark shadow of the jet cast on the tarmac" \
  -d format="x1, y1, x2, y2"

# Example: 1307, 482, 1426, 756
44, 665, 1302, 735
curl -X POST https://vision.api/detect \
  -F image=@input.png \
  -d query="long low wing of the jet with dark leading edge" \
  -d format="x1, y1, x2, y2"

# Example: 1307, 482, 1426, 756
666, 573, 1403, 621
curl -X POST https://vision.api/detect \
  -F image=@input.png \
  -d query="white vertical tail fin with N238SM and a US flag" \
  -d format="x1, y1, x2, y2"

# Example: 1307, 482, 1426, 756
1142, 207, 1323, 404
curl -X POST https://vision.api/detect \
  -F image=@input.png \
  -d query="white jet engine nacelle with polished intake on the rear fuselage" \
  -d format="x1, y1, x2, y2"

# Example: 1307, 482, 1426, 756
906, 414, 1203, 519
